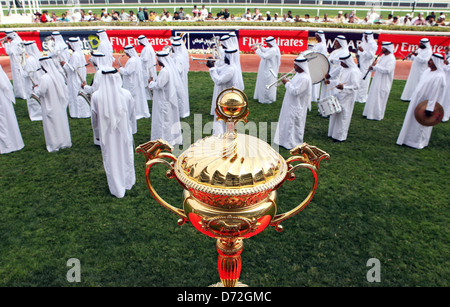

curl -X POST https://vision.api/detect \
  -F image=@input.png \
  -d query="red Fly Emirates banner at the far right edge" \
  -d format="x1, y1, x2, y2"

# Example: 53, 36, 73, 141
378, 33, 450, 59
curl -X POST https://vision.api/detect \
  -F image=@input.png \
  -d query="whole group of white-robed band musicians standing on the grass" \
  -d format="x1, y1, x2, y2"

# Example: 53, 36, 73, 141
0, 30, 450, 197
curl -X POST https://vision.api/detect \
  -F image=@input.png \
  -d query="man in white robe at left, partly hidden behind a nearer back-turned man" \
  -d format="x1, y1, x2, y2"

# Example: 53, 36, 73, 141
22, 41, 44, 121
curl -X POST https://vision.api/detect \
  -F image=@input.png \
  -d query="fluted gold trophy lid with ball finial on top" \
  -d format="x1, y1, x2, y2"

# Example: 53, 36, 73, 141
174, 88, 287, 195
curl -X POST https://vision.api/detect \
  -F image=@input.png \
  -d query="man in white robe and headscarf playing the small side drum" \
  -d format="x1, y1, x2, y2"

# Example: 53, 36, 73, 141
327, 53, 361, 142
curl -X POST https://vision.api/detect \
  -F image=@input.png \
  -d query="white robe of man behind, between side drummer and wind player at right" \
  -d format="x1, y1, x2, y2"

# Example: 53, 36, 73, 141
356, 38, 378, 103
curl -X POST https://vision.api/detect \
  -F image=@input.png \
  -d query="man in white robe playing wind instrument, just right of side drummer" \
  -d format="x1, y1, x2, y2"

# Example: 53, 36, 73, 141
363, 42, 395, 120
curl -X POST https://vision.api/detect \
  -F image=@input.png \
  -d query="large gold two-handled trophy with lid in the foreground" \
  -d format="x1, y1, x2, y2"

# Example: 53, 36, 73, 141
136, 88, 329, 287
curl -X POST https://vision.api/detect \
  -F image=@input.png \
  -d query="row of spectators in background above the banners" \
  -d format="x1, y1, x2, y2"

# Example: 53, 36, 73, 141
30, 5, 450, 26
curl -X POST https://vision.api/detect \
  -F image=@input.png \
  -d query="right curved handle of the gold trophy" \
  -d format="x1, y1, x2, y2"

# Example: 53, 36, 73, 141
270, 143, 330, 232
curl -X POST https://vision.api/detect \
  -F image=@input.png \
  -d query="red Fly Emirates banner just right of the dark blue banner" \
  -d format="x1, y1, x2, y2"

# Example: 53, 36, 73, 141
239, 30, 308, 54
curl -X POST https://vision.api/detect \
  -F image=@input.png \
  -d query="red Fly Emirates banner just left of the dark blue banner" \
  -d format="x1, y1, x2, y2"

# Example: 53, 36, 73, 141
106, 30, 172, 53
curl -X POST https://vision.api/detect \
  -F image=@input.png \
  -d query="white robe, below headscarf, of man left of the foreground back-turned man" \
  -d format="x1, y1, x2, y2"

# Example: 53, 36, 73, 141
35, 74, 72, 152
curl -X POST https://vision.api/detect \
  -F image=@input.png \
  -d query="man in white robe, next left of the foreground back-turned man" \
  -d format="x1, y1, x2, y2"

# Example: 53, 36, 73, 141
34, 57, 72, 152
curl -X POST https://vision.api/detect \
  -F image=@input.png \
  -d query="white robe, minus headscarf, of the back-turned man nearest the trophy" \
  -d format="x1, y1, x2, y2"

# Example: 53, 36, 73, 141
91, 89, 136, 198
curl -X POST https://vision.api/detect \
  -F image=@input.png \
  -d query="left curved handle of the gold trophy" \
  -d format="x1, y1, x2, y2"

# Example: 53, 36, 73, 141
136, 139, 188, 226
